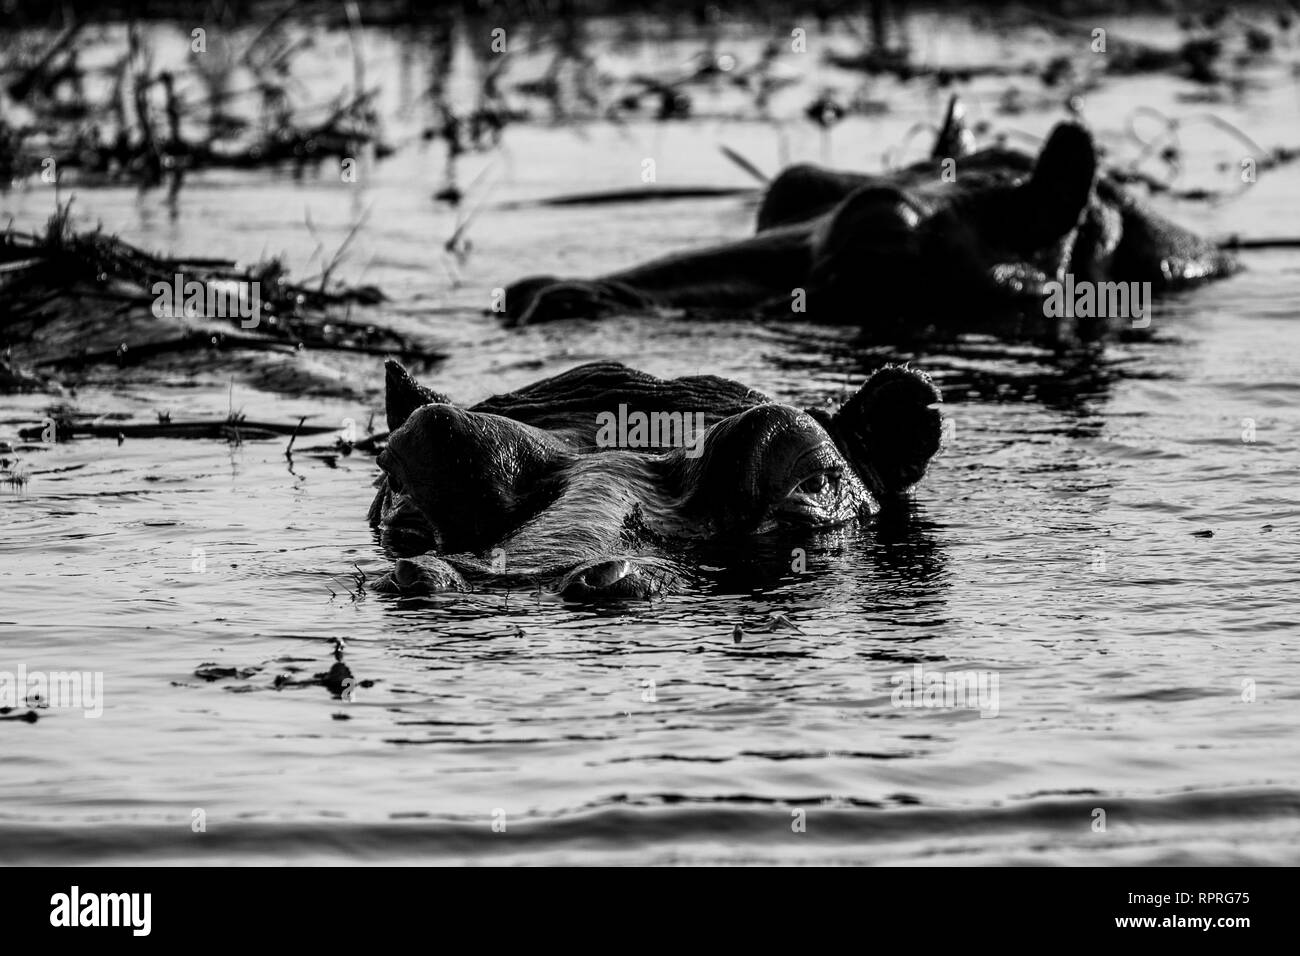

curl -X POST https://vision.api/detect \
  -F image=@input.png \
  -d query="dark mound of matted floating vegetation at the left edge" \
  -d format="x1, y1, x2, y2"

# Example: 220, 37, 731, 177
0, 204, 441, 390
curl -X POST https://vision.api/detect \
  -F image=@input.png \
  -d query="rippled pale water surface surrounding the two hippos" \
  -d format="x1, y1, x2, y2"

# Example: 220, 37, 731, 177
0, 13, 1300, 864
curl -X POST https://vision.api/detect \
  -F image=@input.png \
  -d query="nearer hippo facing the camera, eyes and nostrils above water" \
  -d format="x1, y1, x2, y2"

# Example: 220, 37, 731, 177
369, 360, 941, 601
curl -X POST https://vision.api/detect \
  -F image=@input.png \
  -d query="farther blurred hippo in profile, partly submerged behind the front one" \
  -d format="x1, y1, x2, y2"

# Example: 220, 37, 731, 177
503, 98, 1238, 337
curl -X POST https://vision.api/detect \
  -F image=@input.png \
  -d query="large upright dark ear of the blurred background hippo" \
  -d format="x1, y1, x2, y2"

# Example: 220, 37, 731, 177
1019, 122, 1097, 247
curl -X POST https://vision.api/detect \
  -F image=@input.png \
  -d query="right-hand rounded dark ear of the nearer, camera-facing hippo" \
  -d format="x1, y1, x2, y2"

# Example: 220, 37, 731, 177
814, 365, 943, 497
